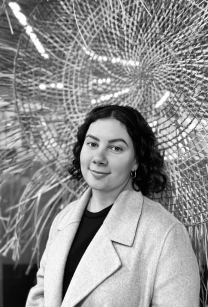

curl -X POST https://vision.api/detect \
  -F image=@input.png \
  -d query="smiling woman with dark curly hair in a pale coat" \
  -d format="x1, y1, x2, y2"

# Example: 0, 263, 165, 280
26, 105, 199, 307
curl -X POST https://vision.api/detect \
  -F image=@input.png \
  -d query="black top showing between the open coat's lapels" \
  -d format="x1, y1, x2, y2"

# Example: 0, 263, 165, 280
63, 205, 112, 298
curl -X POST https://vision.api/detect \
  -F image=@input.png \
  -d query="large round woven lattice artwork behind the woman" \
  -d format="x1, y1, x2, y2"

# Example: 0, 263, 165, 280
1, 0, 208, 282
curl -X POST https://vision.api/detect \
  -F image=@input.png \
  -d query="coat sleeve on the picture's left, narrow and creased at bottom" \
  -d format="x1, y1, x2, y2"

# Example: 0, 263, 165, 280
26, 215, 59, 307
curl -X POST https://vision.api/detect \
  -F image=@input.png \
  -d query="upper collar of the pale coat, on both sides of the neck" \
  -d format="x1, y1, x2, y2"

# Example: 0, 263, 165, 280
58, 181, 144, 246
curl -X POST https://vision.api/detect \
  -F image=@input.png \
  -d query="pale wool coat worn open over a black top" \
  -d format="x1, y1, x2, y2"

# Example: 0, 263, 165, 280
26, 185, 200, 307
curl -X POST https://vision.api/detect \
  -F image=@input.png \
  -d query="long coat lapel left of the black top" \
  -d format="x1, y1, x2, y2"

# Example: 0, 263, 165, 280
44, 190, 91, 307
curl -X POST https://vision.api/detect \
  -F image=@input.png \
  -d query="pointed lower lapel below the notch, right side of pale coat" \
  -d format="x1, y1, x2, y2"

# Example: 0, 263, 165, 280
61, 227, 121, 307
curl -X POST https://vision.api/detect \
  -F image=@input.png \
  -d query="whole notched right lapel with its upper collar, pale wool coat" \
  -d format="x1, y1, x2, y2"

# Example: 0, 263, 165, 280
61, 184, 143, 307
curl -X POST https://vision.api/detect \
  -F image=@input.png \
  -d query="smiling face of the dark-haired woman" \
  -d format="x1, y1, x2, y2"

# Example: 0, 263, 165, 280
80, 118, 137, 195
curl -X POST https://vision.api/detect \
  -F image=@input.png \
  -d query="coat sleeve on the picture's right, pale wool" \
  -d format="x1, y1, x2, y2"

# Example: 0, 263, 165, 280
151, 224, 200, 307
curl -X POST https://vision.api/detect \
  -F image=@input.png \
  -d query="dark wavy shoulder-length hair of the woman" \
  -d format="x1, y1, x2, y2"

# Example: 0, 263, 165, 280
69, 105, 167, 195
